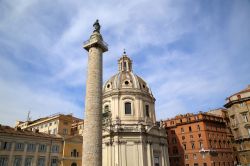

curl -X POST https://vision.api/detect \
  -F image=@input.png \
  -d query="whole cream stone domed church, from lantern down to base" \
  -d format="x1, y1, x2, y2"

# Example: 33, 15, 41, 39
102, 52, 169, 166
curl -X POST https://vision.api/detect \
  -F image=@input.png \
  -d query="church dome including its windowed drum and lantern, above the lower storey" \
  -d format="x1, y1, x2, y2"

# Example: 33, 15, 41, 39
103, 52, 156, 124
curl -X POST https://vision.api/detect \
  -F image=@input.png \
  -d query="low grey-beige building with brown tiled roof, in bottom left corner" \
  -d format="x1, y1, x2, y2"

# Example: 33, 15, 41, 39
0, 125, 63, 166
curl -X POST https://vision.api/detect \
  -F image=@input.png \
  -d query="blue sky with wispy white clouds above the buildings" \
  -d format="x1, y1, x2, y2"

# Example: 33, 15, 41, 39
0, 0, 250, 126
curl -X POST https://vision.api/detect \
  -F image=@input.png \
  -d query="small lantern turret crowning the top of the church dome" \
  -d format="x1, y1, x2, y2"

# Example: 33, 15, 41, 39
118, 49, 132, 72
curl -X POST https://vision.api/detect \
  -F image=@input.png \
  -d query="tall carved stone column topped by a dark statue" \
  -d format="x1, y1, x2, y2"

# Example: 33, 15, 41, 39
82, 20, 108, 166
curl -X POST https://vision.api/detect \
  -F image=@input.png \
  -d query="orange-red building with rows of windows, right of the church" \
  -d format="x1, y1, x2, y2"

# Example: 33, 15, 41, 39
164, 113, 235, 166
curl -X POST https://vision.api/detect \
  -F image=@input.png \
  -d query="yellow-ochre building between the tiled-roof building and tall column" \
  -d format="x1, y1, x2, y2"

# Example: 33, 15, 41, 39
16, 113, 83, 166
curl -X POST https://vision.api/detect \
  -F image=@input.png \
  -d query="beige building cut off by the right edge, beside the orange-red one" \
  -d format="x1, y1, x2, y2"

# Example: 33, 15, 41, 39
224, 85, 250, 165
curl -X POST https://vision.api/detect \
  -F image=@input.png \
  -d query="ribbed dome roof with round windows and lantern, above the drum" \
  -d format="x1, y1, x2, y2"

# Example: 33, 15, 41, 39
103, 52, 153, 97
